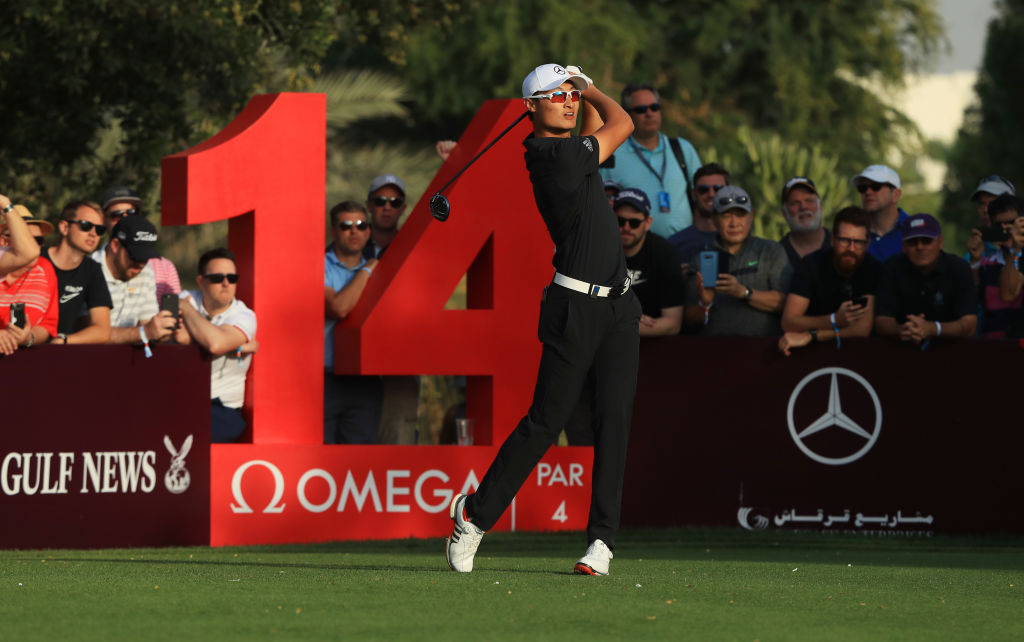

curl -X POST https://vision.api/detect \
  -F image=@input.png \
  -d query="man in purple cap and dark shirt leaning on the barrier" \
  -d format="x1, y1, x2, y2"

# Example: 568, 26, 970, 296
874, 214, 978, 347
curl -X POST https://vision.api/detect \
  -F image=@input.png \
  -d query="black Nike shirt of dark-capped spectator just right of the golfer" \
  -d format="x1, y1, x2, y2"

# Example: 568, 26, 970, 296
626, 232, 683, 318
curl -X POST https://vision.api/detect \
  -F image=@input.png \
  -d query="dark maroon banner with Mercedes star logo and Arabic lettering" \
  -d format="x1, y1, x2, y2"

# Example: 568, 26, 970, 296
623, 337, 1024, 534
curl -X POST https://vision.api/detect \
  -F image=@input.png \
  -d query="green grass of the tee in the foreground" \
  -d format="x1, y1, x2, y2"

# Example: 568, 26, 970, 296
0, 529, 1024, 642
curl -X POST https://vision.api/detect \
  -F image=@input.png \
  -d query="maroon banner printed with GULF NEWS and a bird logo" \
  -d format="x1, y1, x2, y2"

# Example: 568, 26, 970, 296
0, 345, 210, 549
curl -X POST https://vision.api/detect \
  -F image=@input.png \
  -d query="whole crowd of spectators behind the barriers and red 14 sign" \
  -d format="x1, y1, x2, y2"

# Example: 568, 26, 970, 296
0, 79, 1024, 443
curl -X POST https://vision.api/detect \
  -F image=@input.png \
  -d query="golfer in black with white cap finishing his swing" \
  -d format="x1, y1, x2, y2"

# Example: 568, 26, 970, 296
445, 65, 640, 575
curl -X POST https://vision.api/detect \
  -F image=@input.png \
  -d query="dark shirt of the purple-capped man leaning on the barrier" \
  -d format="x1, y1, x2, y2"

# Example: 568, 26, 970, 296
874, 252, 978, 324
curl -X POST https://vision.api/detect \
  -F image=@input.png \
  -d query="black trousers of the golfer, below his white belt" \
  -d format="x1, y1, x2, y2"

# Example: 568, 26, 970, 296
466, 285, 640, 548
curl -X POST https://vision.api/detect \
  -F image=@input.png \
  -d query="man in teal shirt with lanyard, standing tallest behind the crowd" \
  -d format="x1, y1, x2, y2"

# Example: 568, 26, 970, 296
601, 84, 700, 239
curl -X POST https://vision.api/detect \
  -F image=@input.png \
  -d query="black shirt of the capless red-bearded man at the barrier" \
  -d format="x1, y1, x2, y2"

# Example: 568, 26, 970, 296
790, 248, 882, 316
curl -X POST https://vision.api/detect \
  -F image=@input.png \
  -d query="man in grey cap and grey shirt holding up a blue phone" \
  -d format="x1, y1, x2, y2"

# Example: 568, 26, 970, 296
684, 185, 793, 337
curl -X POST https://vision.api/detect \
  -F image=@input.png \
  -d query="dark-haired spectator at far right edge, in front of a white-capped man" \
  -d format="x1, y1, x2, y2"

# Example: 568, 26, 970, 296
974, 192, 1024, 339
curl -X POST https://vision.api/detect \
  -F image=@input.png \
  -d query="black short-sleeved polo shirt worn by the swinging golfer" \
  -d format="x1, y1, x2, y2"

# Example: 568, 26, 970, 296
522, 134, 626, 287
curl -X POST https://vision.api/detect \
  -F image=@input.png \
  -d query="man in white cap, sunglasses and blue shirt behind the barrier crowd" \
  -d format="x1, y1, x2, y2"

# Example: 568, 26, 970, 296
850, 165, 907, 262
